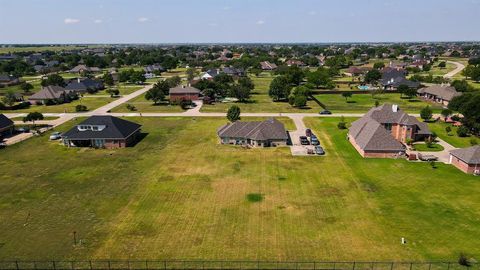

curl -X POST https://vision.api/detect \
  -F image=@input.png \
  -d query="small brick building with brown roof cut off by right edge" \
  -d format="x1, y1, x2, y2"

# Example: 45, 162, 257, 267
450, 145, 480, 175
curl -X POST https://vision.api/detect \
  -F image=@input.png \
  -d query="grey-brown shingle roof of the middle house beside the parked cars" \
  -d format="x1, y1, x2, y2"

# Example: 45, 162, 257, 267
217, 118, 288, 140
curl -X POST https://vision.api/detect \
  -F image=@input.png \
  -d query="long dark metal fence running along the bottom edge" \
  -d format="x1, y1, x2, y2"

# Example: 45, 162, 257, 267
0, 260, 474, 270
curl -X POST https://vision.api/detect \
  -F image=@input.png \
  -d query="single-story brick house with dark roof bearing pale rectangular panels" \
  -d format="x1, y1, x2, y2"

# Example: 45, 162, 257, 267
62, 115, 142, 149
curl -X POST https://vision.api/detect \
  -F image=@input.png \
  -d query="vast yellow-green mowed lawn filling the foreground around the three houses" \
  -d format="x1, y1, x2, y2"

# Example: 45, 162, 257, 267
0, 117, 480, 261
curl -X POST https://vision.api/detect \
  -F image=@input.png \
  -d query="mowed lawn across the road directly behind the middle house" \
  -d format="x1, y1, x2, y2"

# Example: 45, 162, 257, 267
200, 73, 321, 113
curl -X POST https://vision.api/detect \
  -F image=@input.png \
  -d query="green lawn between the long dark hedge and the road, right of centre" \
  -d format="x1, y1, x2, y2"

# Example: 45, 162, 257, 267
315, 92, 442, 113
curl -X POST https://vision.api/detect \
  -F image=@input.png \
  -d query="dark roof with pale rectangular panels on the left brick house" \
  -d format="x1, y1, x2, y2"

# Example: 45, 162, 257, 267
63, 115, 142, 140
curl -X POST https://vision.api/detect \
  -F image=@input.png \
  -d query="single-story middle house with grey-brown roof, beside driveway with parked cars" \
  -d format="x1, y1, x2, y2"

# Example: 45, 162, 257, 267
217, 118, 288, 147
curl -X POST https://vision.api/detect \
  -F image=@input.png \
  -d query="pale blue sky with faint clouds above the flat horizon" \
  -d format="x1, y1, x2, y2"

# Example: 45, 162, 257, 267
0, 0, 480, 43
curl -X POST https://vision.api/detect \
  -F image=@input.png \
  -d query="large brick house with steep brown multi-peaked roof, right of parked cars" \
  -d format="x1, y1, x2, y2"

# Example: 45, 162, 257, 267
348, 104, 432, 158
